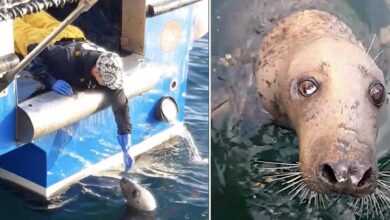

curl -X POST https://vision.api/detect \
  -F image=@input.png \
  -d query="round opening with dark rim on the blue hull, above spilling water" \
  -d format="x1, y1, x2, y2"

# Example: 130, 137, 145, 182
156, 96, 179, 123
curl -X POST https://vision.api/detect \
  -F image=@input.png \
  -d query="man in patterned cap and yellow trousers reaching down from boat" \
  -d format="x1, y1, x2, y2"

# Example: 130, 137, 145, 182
14, 12, 134, 171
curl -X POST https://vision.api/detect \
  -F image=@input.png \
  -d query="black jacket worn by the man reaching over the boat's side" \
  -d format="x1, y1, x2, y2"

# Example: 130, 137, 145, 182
28, 41, 131, 134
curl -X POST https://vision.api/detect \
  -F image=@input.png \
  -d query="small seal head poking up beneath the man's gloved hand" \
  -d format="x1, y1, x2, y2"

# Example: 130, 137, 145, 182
119, 178, 157, 211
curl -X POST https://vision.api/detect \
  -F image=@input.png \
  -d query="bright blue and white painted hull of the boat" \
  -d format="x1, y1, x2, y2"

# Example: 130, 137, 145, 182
0, 0, 198, 198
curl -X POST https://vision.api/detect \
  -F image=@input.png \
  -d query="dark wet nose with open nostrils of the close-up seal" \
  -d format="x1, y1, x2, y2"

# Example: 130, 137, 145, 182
319, 160, 376, 196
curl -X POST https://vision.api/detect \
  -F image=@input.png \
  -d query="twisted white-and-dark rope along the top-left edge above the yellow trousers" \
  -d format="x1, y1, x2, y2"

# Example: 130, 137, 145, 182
0, 0, 78, 22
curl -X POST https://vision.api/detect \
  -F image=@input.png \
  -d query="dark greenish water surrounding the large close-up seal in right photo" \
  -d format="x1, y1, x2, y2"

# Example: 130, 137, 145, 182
211, 0, 390, 220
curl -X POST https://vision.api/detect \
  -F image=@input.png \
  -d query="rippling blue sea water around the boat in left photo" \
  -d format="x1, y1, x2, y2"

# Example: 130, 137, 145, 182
0, 35, 209, 220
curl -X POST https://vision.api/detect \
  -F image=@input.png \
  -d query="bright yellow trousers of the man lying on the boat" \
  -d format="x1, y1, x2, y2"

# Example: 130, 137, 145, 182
14, 11, 86, 56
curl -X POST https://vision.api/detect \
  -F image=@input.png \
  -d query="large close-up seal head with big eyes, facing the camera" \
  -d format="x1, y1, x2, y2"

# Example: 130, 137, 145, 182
256, 10, 386, 197
